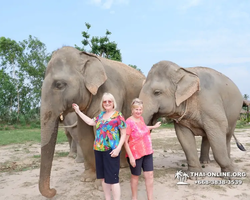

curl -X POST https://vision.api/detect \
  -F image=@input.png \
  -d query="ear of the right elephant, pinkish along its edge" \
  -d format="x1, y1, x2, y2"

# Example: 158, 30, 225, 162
175, 68, 200, 106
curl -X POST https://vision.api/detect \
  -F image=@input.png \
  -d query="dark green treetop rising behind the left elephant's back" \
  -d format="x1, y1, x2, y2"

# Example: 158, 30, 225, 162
75, 23, 122, 61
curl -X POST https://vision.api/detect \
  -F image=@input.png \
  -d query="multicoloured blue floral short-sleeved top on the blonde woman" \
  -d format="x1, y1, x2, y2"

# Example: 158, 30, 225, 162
94, 111, 126, 151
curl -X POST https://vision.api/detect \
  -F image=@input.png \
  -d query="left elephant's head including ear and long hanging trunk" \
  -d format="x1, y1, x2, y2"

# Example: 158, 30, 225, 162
39, 47, 107, 198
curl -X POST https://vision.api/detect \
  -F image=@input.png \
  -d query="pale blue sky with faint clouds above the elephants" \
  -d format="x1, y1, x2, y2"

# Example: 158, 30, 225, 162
0, 0, 250, 96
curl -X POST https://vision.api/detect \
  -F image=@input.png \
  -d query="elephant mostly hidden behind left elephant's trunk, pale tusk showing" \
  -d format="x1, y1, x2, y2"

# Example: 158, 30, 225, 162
60, 112, 84, 163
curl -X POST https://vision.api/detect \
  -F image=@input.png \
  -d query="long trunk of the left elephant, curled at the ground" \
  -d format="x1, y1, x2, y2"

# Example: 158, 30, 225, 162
39, 118, 59, 198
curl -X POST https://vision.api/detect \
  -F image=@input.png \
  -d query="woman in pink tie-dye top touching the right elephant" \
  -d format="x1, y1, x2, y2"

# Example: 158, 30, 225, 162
124, 98, 161, 200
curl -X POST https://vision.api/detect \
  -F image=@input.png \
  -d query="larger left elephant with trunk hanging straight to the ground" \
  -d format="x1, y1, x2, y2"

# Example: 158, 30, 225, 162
39, 46, 145, 198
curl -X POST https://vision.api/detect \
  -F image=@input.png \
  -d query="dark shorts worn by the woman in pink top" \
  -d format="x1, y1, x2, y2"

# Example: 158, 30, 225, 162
127, 154, 154, 176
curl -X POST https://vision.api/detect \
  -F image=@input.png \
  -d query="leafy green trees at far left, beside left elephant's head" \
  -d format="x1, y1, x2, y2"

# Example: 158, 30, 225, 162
0, 36, 51, 122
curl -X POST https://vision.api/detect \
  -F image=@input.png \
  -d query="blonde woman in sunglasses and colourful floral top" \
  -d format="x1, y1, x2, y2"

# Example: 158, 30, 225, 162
73, 93, 126, 200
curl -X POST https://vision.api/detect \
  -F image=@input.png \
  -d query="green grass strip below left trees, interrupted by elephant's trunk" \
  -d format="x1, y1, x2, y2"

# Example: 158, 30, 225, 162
0, 128, 67, 146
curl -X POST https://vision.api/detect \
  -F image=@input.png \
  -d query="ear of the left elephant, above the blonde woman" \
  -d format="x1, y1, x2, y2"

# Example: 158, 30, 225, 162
80, 52, 107, 95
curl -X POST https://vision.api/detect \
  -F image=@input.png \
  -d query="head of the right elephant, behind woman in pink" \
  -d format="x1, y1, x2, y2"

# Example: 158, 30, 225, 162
139, 61, 200, 124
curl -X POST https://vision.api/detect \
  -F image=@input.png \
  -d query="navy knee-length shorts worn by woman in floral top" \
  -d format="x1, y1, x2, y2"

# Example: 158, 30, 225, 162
94, 150, 120, 184
